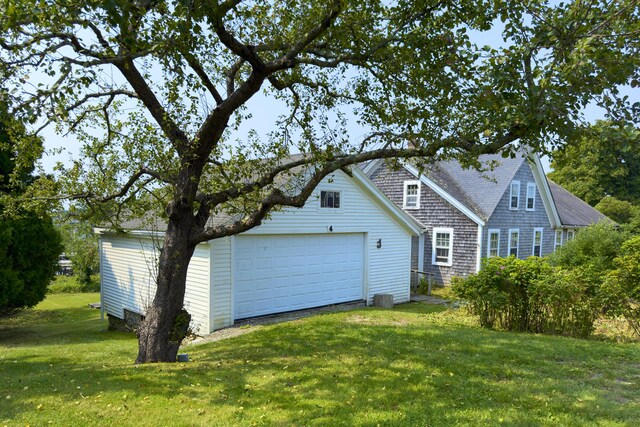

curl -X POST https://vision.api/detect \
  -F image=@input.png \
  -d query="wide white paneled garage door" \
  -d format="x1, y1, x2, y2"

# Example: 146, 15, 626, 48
234, 234, 364, 319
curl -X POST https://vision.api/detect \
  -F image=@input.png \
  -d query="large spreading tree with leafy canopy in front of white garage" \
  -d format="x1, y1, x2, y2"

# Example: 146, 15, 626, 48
0, 0, 640, 362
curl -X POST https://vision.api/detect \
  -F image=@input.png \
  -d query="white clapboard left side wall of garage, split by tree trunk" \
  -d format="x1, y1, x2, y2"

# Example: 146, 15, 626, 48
100, 235, 210, 333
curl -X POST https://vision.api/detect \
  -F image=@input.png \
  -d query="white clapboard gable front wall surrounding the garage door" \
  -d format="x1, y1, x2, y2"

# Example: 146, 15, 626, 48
245, 171, 411, 310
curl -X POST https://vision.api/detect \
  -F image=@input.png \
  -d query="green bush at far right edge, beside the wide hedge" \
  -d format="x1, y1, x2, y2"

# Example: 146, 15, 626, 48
601, 236, 640, 336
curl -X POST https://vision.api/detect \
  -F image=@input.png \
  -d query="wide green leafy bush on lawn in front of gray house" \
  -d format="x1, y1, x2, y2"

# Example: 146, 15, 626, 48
452, 257, 599, 337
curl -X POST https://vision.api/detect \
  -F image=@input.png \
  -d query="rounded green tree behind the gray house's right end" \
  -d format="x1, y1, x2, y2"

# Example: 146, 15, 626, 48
549, 121, 640, 207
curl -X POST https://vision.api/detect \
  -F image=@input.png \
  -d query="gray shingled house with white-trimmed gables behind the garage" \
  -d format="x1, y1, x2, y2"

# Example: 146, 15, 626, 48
363, 153, 603, 284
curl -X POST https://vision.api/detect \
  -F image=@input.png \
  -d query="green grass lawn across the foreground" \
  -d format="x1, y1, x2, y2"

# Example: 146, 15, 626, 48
0, 294, 640, 426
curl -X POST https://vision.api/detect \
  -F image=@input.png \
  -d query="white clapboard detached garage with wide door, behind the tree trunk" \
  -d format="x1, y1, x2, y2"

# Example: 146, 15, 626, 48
97, 168, 420, 334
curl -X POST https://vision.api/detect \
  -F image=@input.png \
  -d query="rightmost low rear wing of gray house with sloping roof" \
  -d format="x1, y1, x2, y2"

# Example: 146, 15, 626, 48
547, 179, 611, 248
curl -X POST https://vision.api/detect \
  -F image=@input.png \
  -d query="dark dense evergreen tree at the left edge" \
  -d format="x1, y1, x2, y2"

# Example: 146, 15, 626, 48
0, 98, 62, 316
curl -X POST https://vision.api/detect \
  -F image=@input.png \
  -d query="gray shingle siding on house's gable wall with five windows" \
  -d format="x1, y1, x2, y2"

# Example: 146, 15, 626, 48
481, 162, 555, 259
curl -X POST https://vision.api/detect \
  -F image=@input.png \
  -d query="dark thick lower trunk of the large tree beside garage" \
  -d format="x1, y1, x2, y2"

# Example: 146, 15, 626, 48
136, 214, 195, 363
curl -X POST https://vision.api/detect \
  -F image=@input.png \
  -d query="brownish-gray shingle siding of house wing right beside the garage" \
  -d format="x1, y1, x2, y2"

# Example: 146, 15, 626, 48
371, 165, 478, 285
